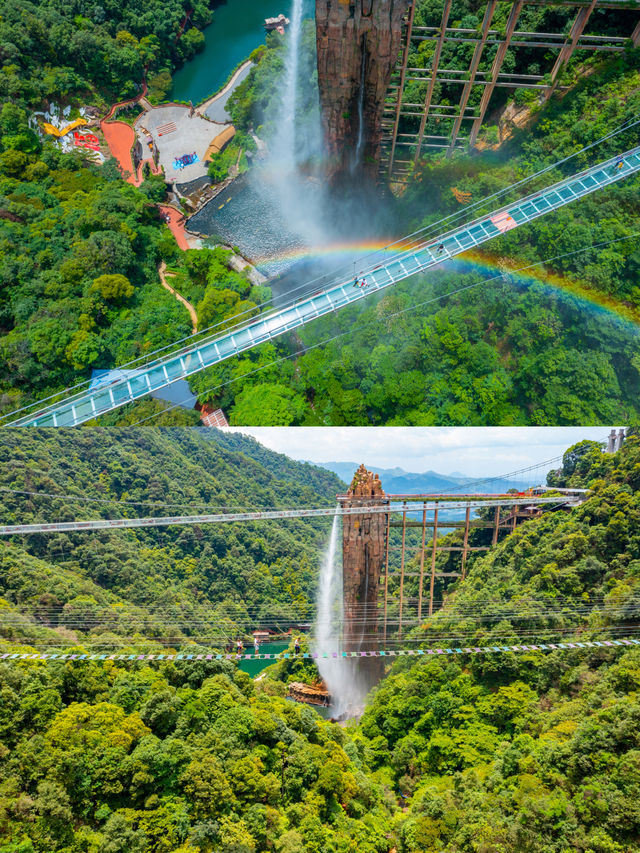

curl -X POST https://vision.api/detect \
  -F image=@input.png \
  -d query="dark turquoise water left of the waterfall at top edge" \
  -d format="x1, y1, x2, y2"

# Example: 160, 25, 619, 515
169, 0, 282, 104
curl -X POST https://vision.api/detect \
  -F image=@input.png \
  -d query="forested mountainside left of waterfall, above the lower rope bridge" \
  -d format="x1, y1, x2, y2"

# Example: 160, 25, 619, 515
0, 429, 344, 645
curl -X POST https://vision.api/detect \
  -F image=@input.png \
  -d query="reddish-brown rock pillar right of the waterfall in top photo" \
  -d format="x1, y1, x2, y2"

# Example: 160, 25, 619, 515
316, 0, 409, 179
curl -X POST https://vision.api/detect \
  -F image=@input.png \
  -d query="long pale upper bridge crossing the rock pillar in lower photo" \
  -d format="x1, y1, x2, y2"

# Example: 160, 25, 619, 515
0, 495, 581, 536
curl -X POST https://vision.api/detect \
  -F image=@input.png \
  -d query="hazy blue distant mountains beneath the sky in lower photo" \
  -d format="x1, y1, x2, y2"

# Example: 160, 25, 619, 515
314, 462, 532, 495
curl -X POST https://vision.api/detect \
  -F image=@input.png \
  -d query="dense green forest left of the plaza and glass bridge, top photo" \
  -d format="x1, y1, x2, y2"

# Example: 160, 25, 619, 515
0, 0, 265, 424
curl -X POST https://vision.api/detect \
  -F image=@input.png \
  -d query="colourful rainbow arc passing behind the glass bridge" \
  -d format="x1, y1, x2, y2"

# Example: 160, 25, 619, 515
254, 241, 640, 329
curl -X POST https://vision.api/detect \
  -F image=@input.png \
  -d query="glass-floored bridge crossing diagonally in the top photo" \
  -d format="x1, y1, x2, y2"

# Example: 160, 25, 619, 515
9, 146, 640, 427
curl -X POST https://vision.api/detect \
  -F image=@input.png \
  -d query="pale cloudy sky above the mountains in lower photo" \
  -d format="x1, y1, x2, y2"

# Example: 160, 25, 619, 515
225, 427, 617, 477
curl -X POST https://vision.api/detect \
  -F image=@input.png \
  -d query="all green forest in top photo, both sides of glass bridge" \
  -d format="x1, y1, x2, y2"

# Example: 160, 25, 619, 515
0, 0, 640, 425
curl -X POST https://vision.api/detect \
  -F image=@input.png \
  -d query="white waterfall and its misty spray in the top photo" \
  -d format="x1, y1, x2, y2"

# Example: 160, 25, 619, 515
215, 0, 393, 280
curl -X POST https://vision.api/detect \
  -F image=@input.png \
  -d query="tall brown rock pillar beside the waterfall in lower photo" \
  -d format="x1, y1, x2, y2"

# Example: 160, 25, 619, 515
340, 465, 389, 690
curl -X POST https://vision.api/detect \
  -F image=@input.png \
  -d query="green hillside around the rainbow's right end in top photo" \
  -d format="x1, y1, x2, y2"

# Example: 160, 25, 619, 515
196, 45, 640, 426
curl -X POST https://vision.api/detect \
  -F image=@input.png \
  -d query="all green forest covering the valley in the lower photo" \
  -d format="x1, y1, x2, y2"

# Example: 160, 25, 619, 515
0, 430, 640, 853
